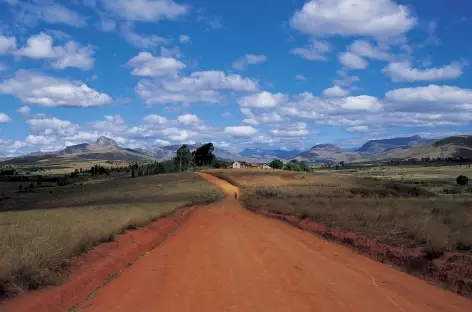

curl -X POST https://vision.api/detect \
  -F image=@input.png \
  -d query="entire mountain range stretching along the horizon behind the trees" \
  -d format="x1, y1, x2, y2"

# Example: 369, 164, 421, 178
0, 135, 472, 164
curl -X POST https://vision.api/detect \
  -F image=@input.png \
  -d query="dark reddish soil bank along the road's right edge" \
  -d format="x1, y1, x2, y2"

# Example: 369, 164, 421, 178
255, 210, 472, 298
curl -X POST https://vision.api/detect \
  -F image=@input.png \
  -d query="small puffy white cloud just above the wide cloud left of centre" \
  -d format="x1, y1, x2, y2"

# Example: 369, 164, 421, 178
127, 52, 186, 77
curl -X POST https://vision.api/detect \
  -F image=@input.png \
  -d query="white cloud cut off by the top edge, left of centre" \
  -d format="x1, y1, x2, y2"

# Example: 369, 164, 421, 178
102, 0, 190, 22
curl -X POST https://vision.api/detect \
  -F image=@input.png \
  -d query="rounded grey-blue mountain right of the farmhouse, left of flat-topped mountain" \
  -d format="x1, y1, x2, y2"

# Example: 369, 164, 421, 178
294, 144, 365, 163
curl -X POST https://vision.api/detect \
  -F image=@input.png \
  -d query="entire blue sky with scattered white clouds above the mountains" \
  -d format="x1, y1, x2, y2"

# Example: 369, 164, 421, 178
0, 0, 472, 156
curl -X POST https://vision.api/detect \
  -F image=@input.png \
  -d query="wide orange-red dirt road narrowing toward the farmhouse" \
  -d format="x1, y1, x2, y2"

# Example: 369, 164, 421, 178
74, 172, 472, 312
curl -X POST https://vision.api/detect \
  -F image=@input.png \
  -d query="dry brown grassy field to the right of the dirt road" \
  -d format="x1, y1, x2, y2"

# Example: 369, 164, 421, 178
211, 167, 472, 253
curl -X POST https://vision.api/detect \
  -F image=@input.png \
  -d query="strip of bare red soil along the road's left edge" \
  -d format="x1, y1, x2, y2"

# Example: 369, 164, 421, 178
0, 207, 195, 312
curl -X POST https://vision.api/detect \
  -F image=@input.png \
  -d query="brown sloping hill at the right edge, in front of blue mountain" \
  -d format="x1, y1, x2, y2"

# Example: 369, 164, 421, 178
376, 135, 472, 159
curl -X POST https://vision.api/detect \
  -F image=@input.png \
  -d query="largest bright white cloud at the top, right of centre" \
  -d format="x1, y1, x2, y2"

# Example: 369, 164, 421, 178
290, 0, 417, 39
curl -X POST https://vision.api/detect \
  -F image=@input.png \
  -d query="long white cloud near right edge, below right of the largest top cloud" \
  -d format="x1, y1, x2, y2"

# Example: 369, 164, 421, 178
383, 61, 465, 82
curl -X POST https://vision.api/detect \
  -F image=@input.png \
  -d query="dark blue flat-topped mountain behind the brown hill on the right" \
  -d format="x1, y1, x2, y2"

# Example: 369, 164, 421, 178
357, 135, 431, 154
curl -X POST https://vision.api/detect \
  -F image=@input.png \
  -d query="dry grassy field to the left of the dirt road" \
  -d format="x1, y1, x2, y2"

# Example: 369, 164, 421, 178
0, 173, 223, 295
